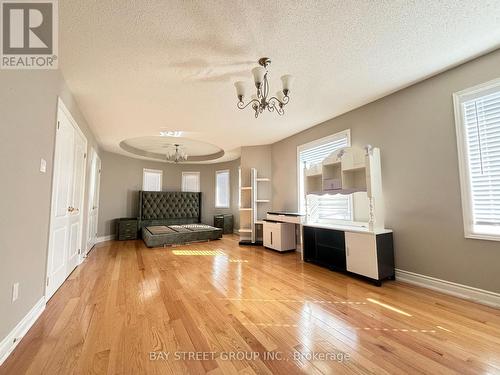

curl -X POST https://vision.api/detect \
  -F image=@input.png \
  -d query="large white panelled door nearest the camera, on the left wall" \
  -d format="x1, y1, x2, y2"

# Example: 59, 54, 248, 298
46, 101, 87, 299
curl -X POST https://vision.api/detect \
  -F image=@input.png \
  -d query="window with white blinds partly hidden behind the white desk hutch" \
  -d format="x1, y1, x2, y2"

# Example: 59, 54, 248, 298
297, 130, 353, 222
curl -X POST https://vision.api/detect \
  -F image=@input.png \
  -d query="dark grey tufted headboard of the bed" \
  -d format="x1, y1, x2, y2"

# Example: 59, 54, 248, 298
139, 191, 201, 228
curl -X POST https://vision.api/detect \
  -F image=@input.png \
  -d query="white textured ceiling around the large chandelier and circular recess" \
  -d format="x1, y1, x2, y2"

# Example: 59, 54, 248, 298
59, 0, 500, 160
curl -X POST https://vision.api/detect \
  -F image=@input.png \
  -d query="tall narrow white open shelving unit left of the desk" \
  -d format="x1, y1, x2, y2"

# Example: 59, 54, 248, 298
239, 168, 271, 244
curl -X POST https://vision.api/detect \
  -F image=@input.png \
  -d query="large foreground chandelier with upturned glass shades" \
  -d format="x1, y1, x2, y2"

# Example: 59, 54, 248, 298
234, 57, 294, 118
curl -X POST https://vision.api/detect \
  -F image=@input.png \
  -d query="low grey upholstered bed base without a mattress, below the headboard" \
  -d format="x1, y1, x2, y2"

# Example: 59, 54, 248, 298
142, 224, 222, 247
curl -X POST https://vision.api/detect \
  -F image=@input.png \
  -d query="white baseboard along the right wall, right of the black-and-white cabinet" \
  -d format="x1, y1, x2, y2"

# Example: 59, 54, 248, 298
396, 269, 500, 308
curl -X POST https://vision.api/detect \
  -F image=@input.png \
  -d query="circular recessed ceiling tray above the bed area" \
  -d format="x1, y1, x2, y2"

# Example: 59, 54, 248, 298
120, 136, 224, 163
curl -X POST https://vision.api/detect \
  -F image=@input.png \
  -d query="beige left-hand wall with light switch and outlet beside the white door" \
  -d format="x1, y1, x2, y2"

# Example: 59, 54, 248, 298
0, 70, 100, 341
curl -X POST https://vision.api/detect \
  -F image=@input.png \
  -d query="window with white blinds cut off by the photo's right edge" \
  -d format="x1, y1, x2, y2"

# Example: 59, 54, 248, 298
453, 79, 500, 241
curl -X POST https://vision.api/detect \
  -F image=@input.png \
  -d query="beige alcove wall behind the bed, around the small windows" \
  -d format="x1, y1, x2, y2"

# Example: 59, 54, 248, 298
98, 152, 240, 236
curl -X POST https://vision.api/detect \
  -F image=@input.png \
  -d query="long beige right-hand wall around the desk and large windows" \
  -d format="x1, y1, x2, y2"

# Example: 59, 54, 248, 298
272, 50, 500, 292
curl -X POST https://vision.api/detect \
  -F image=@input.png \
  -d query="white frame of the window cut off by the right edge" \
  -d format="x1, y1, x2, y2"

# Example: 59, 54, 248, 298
453, 78, 500, 241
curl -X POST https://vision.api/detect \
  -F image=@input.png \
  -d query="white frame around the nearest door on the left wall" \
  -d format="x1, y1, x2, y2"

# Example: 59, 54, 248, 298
44, 96, 88, 301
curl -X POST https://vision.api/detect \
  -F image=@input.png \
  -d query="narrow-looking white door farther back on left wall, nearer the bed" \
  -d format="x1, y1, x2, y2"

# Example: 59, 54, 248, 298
86, 149, 101, 253
